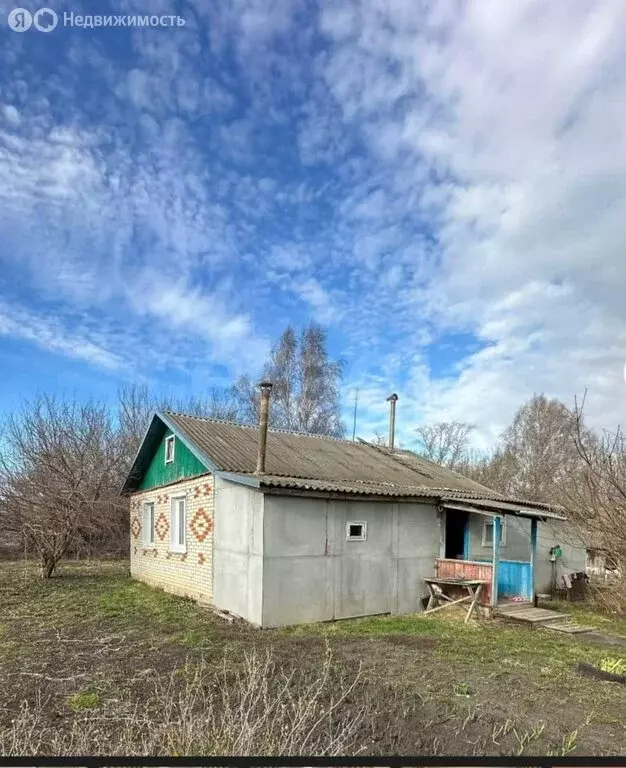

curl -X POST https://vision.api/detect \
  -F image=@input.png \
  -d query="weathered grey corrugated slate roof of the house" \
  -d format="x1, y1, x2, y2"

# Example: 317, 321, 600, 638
125, 411, 557, 517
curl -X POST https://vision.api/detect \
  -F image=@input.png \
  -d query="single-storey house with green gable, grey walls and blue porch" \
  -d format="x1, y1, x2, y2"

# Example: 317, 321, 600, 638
124, 386, 585, 627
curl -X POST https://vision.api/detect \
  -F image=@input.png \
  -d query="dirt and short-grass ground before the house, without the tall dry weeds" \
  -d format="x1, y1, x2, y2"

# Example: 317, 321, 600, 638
0, 562, 626, 756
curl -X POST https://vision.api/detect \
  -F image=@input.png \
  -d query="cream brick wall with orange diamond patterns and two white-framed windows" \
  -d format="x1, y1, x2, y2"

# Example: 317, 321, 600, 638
130, 474, 215, 603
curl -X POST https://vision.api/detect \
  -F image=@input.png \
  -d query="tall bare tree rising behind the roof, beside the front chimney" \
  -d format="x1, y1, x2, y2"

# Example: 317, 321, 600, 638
235, 325, 345, 437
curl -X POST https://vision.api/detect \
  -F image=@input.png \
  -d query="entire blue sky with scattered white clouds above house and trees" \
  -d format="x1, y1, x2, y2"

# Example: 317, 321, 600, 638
0, 0, 626, 447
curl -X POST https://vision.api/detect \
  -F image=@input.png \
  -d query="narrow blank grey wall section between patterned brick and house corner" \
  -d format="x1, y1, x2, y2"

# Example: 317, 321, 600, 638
213, 478, 264, 626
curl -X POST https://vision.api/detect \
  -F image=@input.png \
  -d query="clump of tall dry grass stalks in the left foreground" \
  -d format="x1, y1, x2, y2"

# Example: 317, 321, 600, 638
0, 652, 368, 756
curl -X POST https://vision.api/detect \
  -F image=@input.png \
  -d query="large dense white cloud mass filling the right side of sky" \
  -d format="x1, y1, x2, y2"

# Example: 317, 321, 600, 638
323, 0, 626, 444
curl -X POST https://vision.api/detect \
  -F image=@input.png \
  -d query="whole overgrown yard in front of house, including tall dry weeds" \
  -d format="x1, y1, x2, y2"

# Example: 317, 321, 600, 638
0, 563, 626, 755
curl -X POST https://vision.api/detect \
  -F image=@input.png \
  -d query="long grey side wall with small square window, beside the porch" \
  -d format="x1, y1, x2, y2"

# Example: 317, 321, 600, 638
263, 496, 439, 626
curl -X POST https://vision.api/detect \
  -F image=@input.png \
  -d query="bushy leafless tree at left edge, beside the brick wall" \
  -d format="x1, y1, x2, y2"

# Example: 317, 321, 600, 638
0, 396, 128, 578
